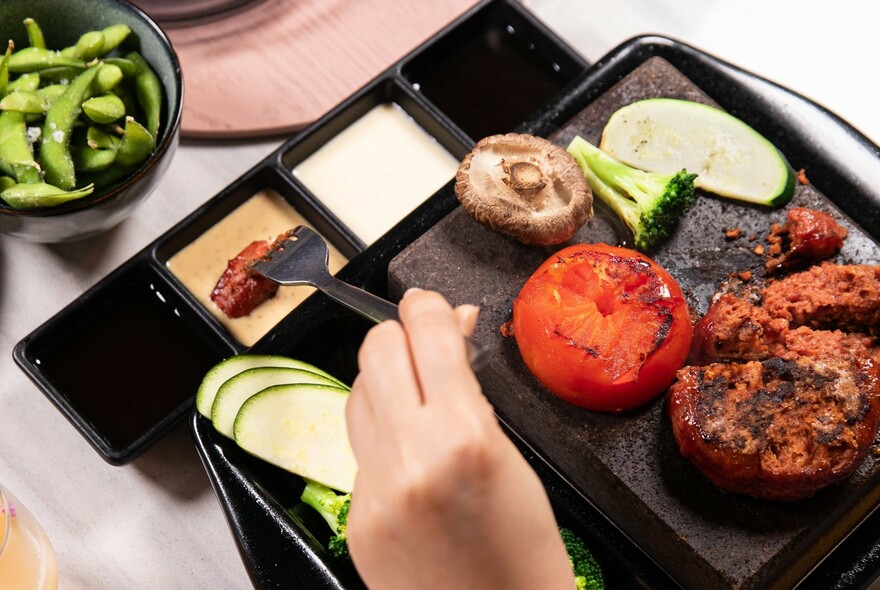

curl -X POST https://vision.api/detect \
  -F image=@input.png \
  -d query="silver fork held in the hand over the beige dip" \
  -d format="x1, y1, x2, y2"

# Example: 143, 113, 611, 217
253, 225, 490, 371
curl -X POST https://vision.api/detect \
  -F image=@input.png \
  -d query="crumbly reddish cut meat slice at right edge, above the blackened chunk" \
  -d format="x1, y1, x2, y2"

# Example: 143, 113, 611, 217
763, 262, 880, 335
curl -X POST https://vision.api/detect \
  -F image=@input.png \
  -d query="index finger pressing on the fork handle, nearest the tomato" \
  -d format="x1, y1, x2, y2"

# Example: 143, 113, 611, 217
400, 290, 478, 403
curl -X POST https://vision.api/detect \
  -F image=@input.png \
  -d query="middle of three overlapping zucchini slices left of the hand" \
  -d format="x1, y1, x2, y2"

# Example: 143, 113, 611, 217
211, 367, 341, 438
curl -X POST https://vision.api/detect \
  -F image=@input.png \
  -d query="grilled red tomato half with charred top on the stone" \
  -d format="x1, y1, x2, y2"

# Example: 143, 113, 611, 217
513, 244, 693, 412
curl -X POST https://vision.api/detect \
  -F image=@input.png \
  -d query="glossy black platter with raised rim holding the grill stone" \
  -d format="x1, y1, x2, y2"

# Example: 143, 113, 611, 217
191, 36, 880, 589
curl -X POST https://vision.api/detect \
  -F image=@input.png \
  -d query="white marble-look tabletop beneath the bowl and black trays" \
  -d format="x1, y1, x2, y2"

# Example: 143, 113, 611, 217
0, 0, 880, 590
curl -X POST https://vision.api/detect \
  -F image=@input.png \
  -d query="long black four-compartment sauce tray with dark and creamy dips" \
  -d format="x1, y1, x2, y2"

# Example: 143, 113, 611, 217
13, 0, 587, 464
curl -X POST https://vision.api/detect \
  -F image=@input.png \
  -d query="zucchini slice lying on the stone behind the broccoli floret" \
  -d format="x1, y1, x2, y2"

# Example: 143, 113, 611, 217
599, 98, 795, 207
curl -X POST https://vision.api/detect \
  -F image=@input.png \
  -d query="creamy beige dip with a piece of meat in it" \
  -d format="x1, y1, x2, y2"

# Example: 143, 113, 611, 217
167, 190, 347, 346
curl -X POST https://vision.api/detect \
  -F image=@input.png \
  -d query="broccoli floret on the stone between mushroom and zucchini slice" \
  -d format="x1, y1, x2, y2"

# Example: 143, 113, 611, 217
568, 137, 697, 251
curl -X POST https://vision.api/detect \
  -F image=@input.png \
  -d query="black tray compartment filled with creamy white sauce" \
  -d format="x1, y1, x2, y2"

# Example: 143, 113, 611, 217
282, 77, 467, 245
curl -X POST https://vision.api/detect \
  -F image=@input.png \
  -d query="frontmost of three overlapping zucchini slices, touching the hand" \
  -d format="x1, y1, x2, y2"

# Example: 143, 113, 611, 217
233, 383, 357, 492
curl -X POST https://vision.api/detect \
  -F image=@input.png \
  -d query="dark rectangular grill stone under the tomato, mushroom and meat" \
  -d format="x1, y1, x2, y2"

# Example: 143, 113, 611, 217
389, 58, 880, 589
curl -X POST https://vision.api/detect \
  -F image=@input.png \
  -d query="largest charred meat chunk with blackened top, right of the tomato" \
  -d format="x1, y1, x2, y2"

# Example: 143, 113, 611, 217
668, 356, 880, 500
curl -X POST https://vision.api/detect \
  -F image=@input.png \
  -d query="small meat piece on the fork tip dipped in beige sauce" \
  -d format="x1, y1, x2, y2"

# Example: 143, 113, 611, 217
211, 240, 278, 318
